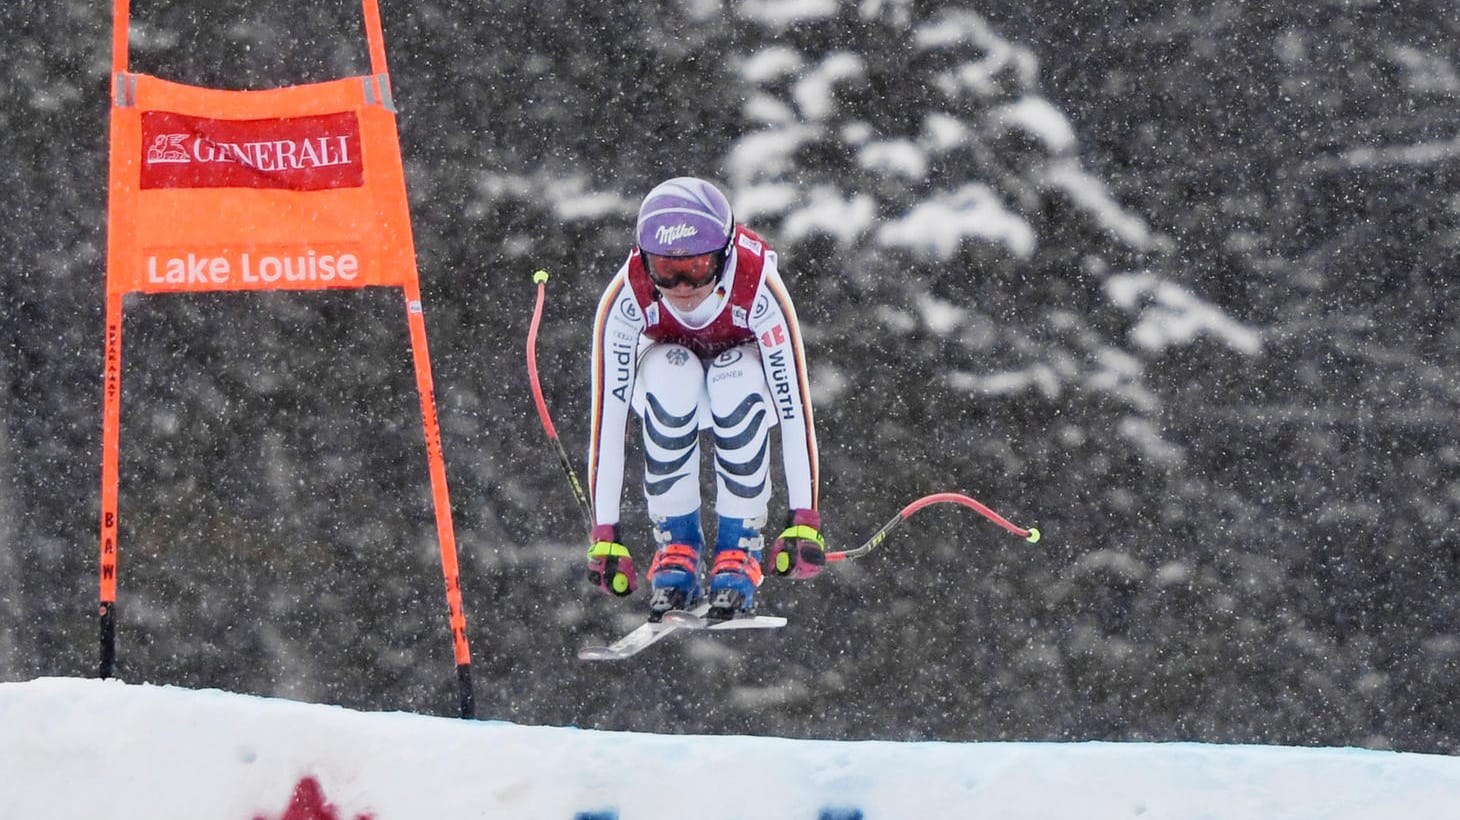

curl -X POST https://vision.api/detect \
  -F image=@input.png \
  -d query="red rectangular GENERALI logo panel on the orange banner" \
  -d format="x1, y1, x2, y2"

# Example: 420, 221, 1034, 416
142, 111, 365, 191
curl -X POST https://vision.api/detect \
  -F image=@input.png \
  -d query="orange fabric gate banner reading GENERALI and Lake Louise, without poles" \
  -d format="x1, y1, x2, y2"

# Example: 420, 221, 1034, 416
107, 73, 416, 293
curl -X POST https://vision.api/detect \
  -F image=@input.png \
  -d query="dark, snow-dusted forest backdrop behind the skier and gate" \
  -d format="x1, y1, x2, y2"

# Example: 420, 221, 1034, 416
0, 0, 1460, 753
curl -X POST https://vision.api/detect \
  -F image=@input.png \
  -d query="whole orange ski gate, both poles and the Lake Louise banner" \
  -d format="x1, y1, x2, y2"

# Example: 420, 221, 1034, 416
99, 0, 475, 718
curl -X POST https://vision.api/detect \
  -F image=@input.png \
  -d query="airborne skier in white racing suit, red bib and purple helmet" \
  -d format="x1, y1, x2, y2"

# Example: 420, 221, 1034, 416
588, 177, 826, 622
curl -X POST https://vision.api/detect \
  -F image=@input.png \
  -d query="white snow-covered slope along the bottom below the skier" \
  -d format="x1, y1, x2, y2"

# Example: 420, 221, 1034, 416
0, 678, 1460, 820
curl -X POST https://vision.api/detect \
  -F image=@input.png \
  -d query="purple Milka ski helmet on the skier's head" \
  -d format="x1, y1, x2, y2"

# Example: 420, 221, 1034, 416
634, 177, 734, 257
